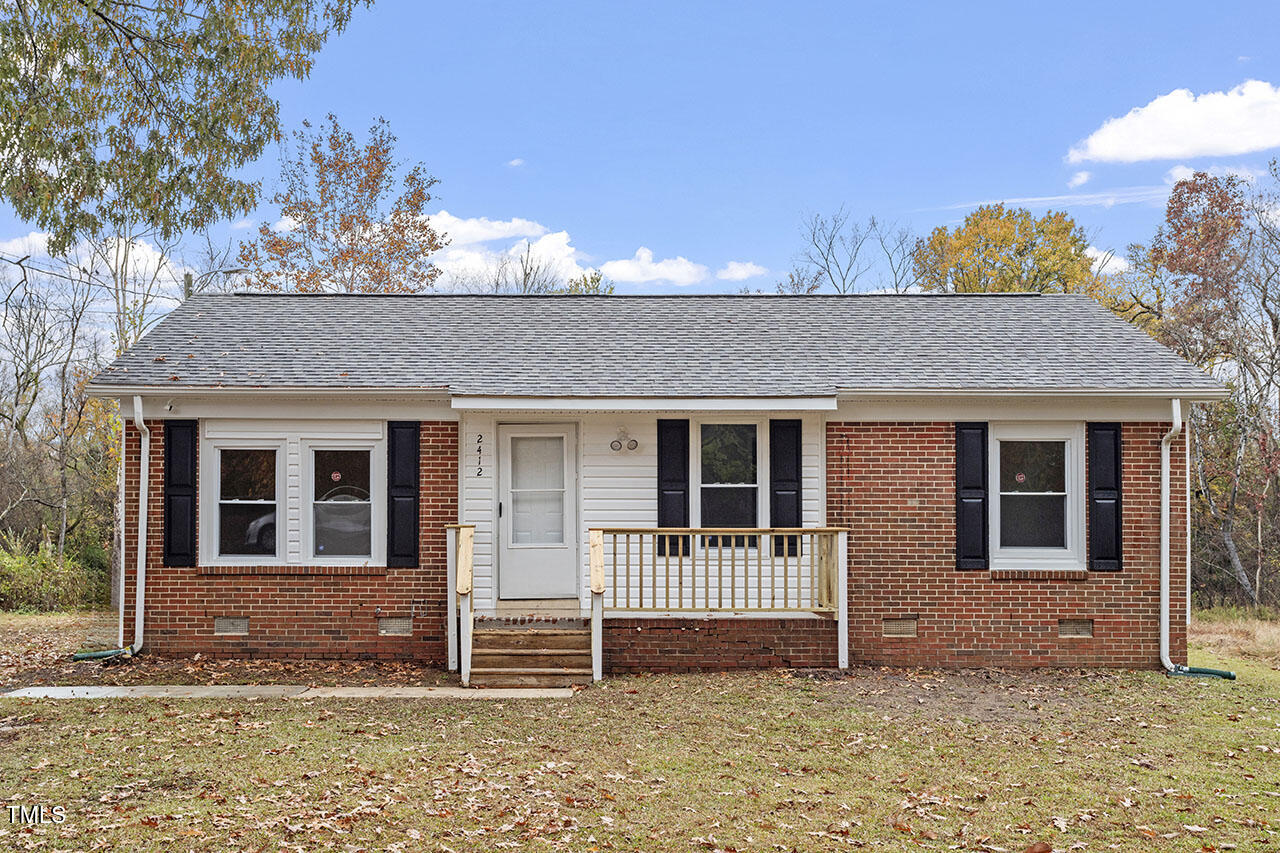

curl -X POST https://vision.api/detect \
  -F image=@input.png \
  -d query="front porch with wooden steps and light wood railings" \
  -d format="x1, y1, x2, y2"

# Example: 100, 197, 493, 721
447, 524, 849, 686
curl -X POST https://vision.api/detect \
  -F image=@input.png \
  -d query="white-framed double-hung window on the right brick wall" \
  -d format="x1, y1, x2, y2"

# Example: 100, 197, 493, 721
989, 424, 1084, 569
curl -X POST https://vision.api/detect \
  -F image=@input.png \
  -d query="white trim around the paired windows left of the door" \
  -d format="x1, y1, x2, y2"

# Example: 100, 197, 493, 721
200, 420, 387, 567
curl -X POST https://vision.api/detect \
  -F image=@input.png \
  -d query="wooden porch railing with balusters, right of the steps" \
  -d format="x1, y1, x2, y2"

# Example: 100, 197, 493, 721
589, 528, 847, 613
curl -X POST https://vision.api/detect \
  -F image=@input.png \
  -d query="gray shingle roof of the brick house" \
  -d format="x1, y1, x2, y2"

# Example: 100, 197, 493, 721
85, 295, 1221, 397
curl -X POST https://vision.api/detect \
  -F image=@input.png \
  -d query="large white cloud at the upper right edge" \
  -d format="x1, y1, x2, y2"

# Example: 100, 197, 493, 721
1066, 79, 1280, 163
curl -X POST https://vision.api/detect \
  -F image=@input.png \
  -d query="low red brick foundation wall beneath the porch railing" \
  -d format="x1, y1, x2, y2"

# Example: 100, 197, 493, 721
604, 619, 836, 674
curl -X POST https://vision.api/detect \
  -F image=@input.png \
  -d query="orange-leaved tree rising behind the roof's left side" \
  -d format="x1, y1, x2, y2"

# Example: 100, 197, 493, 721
239, 113, 448, 293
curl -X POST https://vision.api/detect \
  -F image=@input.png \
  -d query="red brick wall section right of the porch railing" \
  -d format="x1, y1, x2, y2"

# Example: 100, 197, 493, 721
827, 423, 1187, 669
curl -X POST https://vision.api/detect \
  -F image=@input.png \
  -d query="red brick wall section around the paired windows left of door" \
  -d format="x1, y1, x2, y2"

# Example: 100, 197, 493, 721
124, 420, 458, 662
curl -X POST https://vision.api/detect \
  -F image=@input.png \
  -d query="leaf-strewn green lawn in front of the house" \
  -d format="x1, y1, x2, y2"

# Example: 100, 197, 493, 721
0, 614, 1280, 852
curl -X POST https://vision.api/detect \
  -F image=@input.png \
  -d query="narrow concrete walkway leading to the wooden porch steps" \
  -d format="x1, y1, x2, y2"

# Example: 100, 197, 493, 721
0, 684, 573, 699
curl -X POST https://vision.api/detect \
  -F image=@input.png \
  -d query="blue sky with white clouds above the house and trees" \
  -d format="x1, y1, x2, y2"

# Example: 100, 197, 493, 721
0, 0, 1280, 292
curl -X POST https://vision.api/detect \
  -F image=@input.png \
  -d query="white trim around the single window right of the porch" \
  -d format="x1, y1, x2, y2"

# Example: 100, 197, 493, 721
987, 421, 1085, 570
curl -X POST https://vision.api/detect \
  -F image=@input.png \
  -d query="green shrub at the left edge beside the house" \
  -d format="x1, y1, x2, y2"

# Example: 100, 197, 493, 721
0, 540, 103, 611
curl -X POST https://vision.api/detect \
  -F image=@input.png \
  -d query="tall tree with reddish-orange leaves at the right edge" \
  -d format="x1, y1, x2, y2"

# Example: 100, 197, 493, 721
1126, 163, 1280, 605
